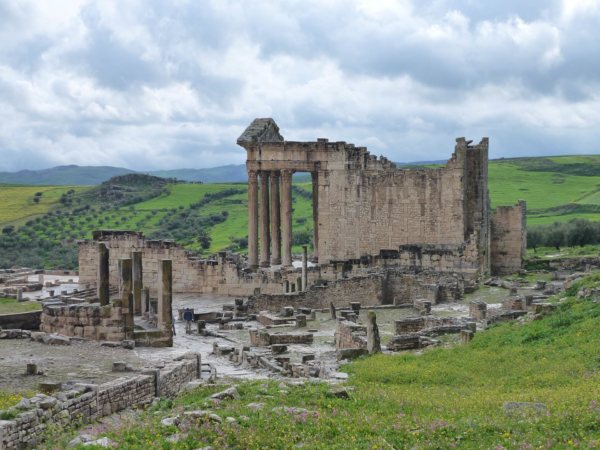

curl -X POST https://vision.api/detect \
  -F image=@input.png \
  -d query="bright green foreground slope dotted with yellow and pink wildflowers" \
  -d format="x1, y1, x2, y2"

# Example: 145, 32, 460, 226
35, 273, 600, 450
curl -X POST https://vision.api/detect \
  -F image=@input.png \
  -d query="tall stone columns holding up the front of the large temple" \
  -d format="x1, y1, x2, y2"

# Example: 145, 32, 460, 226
248, 170, 319, 269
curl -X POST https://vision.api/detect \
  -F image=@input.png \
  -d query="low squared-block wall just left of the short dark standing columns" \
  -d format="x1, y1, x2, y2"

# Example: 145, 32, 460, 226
40, 303, 125, 341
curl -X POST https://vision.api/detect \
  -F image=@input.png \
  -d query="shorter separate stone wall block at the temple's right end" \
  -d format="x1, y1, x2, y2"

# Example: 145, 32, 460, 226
491, 200, 527, 276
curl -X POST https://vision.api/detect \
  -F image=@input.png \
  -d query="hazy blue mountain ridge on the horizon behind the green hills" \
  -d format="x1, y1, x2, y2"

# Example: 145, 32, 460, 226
0, 160, 466, 186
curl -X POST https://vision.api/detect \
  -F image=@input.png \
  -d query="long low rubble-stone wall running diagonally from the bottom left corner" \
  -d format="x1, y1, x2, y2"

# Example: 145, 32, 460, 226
0, 355, 200, 450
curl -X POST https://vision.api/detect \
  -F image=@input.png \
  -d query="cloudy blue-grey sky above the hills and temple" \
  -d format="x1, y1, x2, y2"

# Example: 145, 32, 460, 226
0, 0, 600, 171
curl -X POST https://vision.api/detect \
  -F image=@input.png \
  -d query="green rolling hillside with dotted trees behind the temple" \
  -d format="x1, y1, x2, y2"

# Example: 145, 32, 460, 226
5, 156, 600, 264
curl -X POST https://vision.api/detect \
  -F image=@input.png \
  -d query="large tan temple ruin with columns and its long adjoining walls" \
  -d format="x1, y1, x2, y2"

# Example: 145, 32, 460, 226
79, 119, 526, 310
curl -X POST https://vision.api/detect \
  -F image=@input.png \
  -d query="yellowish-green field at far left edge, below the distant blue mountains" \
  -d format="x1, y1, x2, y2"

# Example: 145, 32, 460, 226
0, 184, 87, 225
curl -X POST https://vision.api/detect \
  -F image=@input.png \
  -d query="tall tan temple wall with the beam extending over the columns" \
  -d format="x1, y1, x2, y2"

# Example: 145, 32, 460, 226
248, 138, 489, 271
